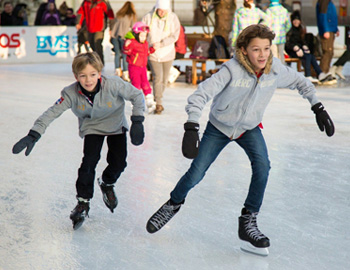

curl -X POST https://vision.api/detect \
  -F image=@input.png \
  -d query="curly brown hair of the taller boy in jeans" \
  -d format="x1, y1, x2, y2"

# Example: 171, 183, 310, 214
236, 24, 276, 49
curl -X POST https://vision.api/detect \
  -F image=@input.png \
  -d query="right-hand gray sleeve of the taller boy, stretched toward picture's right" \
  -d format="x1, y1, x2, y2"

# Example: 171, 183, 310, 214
274, 58, 319, 106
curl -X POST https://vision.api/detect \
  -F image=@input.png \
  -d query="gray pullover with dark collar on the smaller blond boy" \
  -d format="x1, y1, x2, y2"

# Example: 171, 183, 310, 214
32, 76, 145, 138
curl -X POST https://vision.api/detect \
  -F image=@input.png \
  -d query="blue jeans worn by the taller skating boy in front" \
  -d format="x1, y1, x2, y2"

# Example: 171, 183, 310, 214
170, 122, 270, 212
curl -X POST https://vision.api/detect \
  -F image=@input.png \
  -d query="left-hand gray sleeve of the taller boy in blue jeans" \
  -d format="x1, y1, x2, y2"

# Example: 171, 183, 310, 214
185, 65, 232, 123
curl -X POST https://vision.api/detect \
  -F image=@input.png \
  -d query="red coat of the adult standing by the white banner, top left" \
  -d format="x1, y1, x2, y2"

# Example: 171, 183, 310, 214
77, 0, 114, 33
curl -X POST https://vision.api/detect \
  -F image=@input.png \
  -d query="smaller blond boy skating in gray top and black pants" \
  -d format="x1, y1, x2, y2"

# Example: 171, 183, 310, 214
12, 52, 144, 229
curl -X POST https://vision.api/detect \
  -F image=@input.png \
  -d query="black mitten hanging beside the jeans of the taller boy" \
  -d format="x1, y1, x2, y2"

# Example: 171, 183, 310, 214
182, 122, 199, 159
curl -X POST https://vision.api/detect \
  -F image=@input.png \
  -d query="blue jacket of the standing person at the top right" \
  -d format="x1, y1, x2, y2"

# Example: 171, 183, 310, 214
316, 1, 338, 37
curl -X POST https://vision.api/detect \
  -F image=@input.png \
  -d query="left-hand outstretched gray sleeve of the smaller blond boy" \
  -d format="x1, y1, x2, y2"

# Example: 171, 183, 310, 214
31, 90, 72, 135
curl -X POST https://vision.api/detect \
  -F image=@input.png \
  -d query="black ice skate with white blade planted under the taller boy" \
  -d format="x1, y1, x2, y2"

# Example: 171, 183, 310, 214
238, 208, 270, 256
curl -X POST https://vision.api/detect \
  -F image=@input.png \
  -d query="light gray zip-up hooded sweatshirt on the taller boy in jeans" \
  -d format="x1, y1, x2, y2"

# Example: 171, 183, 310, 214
186, 50, 318, 139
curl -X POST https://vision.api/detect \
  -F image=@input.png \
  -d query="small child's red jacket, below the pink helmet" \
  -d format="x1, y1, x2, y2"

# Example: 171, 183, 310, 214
123, 39, 155, 67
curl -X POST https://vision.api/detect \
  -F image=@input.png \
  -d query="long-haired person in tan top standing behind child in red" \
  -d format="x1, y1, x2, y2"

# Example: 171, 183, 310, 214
111, 1, 136, 81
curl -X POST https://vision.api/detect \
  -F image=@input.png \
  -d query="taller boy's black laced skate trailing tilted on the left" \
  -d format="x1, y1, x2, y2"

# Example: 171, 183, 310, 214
146, 200, 181, 233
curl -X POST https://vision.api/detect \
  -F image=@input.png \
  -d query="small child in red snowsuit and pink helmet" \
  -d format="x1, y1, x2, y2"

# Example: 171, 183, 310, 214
123, 22, 156, 113
